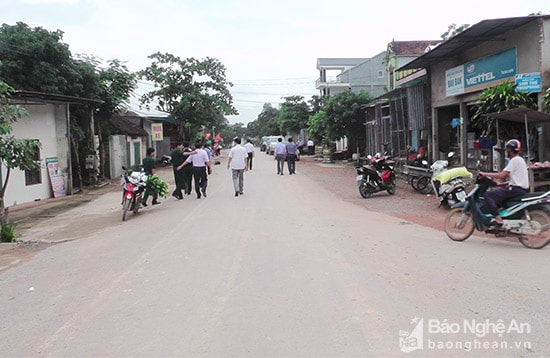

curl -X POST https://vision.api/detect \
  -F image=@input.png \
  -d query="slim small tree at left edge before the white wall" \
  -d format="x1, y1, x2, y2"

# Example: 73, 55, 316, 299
0, 78, 40, 241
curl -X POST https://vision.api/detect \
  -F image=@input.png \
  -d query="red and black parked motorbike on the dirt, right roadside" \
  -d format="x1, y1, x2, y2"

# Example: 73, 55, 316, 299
355, 154, 395, 199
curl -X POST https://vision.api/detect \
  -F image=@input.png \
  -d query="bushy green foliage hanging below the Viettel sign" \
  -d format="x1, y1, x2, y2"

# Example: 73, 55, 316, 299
472, 82, 537, 138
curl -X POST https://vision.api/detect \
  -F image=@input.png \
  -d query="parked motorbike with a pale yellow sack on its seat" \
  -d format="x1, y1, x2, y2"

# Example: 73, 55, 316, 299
430, 160, 472, 207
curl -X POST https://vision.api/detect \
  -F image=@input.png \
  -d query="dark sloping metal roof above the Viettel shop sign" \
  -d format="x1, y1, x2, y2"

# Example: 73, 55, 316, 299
398, 15, 550, 71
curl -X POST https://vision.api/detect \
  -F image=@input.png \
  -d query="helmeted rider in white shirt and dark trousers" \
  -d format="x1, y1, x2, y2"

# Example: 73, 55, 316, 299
479, 139, 529, 225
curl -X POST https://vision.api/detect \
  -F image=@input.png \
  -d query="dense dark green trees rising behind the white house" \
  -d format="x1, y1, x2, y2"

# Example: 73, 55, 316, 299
0, 22, 136, 185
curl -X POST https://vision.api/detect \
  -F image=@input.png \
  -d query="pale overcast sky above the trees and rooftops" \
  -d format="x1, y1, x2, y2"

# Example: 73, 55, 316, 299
0, 0, 550, 125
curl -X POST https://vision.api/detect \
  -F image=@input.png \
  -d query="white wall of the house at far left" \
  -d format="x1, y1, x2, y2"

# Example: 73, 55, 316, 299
2, 104, 68, 207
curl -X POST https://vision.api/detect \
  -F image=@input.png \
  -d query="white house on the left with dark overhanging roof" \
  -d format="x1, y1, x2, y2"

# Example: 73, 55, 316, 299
0, 91, 101, 207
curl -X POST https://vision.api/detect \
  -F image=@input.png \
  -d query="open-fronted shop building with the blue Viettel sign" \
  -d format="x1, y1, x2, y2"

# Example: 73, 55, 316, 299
397, 15, 550, 170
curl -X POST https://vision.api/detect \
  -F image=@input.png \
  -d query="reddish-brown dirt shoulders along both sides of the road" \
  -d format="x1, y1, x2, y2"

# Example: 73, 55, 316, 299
0, 153, 447, 272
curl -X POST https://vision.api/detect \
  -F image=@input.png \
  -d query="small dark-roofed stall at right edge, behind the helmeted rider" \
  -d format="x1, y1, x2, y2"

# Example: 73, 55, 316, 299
487, 107, 550, 192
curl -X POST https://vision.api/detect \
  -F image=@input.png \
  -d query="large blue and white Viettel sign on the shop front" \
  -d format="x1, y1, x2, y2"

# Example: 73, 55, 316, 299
445, 48, 517, 97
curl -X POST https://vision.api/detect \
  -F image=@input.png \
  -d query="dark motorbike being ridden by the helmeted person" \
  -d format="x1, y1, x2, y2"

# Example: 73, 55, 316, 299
445, 176, 550, 249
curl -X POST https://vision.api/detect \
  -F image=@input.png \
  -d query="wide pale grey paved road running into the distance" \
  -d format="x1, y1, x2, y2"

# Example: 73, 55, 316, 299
0, 153, 550, 357
